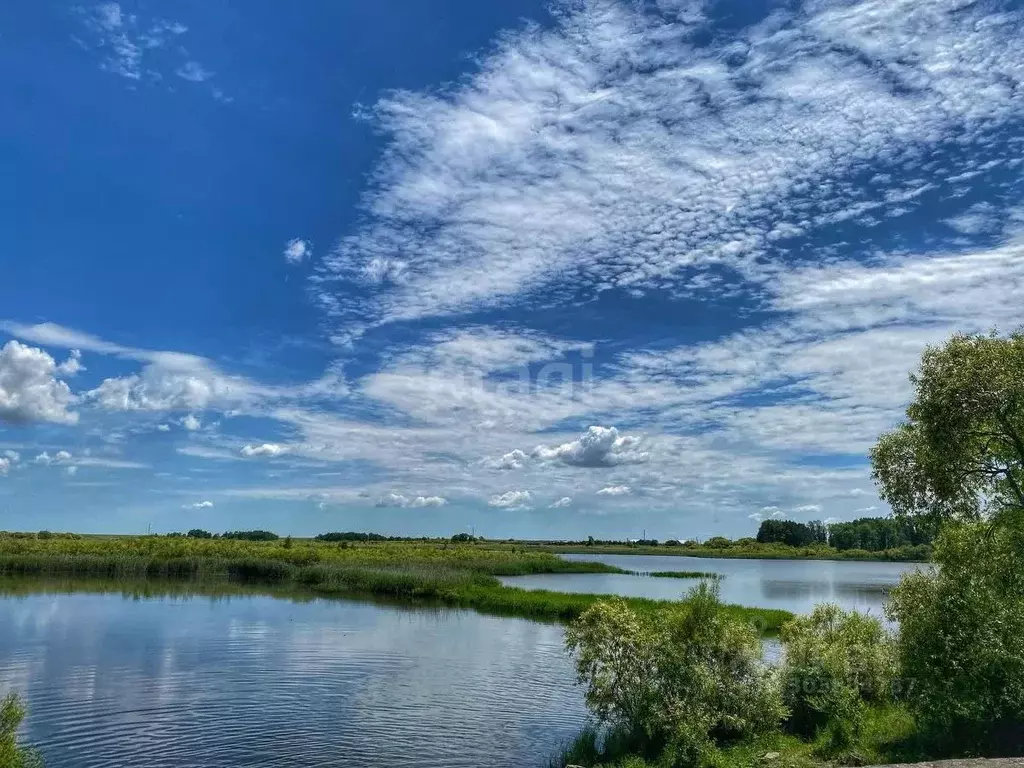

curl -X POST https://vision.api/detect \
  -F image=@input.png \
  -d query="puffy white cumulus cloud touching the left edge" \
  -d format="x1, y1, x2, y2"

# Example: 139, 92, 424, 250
0, 341, 78, 424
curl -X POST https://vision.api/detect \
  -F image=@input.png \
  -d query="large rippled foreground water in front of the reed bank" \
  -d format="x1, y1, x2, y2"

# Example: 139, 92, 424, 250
0, 594, 586, 768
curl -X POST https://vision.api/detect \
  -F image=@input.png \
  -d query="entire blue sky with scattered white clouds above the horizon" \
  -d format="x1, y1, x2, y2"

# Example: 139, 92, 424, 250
0, 0, 1024, 539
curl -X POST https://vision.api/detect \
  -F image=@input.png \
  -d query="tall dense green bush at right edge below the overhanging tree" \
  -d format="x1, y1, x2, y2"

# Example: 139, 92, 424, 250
888, 521, 1024, 754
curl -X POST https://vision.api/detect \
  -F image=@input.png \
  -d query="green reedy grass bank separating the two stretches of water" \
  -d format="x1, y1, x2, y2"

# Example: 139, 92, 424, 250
0, 535, 792, 634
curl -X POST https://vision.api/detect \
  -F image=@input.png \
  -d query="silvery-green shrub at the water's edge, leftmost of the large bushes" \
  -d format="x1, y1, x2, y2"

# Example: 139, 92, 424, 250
566, 584, 784, 766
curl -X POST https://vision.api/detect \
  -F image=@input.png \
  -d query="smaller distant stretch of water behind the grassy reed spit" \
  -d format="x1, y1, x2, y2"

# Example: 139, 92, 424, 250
502, 555, 923, 617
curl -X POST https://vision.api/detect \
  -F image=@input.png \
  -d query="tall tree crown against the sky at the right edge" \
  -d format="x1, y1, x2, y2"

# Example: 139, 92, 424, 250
871, 331, 1024, 527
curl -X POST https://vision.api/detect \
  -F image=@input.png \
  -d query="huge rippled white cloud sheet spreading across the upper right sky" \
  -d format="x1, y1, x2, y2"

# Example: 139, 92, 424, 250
318, 0, 1024, 322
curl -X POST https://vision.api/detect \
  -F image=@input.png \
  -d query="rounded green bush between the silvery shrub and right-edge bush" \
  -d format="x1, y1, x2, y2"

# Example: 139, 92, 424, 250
781, 604, 894, 749
